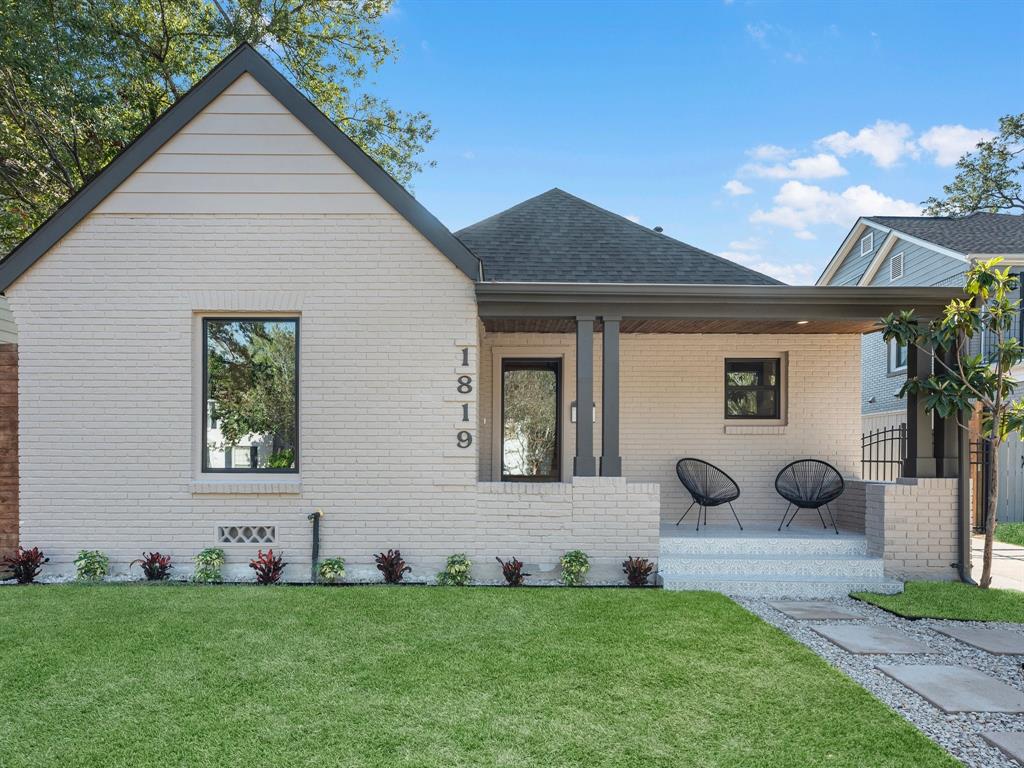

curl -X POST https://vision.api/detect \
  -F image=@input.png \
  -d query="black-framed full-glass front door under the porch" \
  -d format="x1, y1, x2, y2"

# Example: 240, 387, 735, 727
501, 358, 562, 481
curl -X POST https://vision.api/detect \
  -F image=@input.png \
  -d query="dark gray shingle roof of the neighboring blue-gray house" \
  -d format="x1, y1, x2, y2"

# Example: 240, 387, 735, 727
865, 213, 1024, 253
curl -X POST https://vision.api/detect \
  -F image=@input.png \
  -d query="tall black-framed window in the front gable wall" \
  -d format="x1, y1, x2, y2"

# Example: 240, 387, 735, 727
203, 317, 299, 472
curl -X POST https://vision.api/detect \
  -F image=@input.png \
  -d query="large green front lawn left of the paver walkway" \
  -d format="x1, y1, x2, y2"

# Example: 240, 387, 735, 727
0, 586, 957, 768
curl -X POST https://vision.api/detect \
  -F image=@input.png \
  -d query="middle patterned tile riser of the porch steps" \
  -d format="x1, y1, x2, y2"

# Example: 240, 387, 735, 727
657, 555, 885, 581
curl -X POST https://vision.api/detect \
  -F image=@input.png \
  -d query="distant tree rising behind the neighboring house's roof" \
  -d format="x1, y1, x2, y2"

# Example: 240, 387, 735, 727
924, 113, 1024, 216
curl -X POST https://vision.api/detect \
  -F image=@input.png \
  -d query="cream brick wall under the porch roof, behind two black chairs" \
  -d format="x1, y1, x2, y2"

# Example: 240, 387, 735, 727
480, 334, 860, 522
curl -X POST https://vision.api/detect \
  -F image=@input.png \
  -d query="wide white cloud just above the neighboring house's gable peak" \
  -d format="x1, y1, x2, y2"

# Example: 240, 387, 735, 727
750, 181, 921, 231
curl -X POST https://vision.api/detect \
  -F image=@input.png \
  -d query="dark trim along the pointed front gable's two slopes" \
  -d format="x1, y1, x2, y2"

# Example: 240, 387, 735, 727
0, 43, 480, 291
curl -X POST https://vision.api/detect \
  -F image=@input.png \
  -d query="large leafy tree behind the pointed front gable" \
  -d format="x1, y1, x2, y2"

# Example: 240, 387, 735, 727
0, 0, 434, 254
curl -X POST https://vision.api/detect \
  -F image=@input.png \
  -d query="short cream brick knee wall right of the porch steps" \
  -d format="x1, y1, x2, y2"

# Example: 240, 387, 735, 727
864, 477, 958, 581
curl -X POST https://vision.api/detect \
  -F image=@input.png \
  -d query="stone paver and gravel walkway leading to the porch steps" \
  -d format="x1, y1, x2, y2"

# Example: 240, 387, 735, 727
735, 598, 1024, 768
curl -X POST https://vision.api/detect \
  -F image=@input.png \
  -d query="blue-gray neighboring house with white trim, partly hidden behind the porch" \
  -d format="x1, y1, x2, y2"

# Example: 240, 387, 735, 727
817, 212, 1024, 522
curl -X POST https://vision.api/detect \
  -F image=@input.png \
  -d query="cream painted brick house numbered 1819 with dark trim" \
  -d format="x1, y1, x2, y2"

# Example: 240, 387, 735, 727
0, 45, 967, 594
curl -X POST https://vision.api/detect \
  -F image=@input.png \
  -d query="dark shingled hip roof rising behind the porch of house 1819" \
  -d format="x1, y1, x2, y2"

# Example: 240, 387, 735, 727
456, 187, 781, 286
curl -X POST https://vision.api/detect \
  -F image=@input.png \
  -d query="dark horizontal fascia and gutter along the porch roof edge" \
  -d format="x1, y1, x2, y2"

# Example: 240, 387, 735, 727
476, 283, 963, 322
